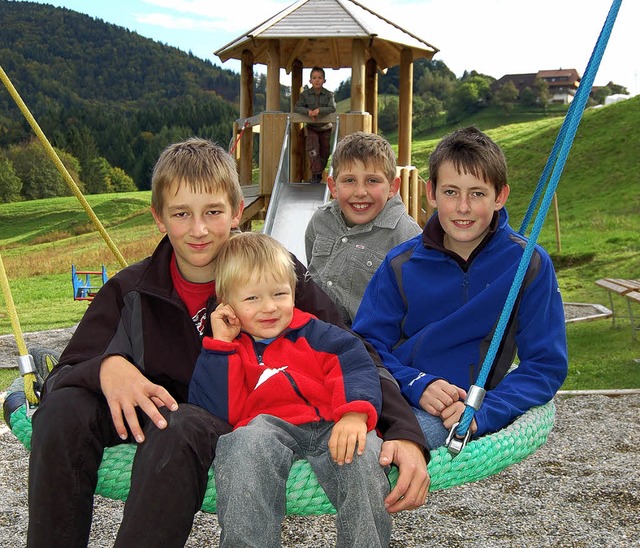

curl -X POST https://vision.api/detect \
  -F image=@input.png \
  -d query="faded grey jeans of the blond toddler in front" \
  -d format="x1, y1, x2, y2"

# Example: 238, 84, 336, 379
214, 415, 391, 548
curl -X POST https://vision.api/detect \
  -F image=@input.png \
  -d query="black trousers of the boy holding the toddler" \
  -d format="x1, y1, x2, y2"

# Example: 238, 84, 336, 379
27, 388, 231, 548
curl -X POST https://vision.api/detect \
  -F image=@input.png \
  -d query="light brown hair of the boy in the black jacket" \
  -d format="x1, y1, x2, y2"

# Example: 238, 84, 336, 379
151, 137, 243, 213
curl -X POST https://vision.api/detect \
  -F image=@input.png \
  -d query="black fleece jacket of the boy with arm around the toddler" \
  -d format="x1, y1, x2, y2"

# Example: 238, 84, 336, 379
44, 237, 429, 459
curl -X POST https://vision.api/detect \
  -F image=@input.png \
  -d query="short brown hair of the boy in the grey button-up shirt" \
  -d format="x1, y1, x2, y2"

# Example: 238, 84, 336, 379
331, 131, 396, 183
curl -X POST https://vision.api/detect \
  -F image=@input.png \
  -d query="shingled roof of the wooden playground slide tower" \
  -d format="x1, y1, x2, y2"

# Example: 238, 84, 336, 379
215, 0, 439, 72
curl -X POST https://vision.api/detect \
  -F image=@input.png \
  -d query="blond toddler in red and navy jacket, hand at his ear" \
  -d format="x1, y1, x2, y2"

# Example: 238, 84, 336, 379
189, 232, 391, 546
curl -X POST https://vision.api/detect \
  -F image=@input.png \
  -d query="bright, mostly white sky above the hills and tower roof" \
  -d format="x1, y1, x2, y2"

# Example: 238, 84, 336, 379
22, 0, 640, 95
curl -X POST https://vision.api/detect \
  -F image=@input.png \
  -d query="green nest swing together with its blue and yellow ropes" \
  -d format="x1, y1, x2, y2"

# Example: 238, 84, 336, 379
0, 0, 622, 515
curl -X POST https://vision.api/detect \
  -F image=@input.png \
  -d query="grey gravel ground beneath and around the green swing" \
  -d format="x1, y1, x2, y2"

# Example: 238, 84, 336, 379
0, 318, 640, 548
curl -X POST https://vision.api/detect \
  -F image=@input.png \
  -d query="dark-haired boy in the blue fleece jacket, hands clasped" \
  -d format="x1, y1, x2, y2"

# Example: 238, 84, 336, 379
352, 127, 568, 449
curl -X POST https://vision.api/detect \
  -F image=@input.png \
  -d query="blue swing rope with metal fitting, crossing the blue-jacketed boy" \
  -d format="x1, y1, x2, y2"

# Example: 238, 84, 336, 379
447, 0, 622, 448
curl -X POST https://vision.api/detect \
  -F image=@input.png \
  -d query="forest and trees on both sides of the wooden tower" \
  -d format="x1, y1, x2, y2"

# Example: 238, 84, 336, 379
0, 0, 624, 202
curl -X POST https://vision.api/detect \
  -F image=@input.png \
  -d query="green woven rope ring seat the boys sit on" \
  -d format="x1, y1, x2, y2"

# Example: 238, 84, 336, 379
10, 390, 555, 516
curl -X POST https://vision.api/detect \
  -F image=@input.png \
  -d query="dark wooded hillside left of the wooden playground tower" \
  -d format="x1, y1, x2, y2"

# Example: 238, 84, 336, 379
0, 0, 246, 201
